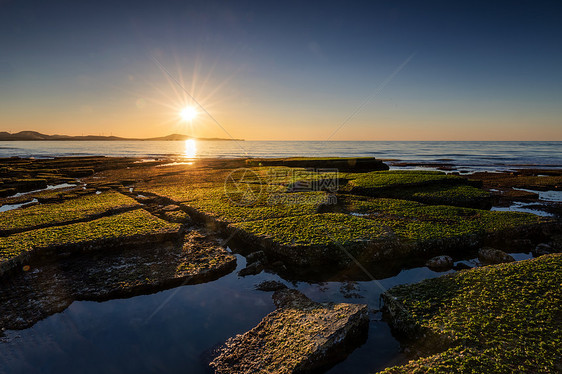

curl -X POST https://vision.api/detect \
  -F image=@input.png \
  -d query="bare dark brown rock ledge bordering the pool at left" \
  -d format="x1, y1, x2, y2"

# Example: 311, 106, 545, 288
0, 231, 236, 331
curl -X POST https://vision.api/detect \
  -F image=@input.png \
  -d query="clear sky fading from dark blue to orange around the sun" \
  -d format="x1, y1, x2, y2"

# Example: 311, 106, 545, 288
0, 0, 562, 140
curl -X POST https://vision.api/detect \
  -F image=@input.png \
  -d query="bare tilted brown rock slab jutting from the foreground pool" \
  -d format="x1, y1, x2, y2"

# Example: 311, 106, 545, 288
210, 290, 369, 373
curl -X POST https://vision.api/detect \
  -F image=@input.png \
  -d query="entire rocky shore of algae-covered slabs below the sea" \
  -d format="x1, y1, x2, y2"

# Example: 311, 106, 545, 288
0, 157, 562, 373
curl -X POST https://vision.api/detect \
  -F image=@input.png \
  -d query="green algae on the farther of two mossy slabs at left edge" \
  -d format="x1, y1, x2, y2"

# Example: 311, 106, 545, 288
0, 192, 140, 232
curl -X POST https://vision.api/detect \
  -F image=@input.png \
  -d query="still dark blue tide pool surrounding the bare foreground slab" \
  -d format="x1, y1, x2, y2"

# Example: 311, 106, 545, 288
0, 253, 532, 374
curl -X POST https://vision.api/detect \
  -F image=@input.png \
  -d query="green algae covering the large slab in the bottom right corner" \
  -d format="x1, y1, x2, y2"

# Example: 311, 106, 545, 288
378, 255, 562, 373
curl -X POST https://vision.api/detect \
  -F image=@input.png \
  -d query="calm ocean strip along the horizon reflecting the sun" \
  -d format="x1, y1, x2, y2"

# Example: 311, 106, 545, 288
0, 141, 562, 169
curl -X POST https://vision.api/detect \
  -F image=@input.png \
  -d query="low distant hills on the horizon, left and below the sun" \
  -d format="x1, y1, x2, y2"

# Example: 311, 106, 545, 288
0, 131, 240, 141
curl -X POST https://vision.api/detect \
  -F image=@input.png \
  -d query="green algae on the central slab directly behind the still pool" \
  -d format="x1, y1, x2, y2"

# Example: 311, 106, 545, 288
233, 199, 541, 263
